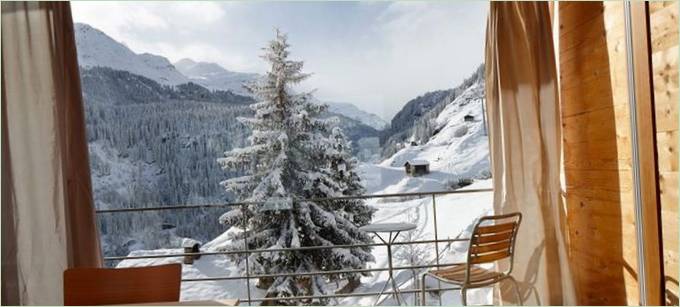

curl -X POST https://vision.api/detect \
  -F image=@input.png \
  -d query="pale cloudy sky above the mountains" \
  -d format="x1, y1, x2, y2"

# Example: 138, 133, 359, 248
71, 1, 488, 120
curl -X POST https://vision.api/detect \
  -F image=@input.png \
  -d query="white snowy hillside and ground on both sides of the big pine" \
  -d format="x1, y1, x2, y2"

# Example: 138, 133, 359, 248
114, 69, 493, 306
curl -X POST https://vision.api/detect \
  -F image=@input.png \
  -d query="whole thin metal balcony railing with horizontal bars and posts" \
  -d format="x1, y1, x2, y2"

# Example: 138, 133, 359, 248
96, 189, 493, 305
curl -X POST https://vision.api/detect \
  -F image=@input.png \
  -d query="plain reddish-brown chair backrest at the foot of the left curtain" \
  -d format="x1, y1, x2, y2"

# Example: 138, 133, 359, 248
64, 264, 182, 306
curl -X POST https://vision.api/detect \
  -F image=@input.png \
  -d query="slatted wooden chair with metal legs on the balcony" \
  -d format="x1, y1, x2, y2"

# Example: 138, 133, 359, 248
420, 213, 523, 305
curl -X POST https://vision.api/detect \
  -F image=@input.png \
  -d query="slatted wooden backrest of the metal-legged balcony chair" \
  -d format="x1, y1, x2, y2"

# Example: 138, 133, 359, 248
467, 212, 522, 275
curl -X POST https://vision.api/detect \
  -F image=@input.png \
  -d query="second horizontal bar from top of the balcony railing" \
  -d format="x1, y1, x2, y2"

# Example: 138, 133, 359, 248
104, 238, 470, 261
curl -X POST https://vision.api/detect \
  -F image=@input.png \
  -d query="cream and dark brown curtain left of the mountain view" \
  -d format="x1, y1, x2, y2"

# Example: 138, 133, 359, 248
2, 2, 101, 305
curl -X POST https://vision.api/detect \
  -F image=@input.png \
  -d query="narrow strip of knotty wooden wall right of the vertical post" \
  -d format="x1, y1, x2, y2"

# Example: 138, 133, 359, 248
649, 1, 680, 305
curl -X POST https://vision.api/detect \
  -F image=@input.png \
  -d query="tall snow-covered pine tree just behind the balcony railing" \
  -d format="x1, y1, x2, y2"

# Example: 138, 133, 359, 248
218, 30, 373, 304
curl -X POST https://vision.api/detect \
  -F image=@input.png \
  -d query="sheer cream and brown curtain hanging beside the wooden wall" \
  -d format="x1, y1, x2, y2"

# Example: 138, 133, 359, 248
486, 2, 576, 305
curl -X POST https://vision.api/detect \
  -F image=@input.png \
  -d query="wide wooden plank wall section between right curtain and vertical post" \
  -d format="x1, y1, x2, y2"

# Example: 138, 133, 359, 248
559, 2, 639, 305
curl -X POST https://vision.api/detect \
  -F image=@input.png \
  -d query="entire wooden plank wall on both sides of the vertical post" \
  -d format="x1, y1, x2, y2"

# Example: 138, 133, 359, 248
558, 1, 680, 305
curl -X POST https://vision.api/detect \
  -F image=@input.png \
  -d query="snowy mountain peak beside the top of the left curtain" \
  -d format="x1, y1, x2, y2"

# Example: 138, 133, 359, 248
75, 23, 189, 85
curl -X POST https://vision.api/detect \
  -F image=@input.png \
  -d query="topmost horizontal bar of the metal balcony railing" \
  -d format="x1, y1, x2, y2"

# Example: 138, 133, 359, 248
95, 189, 493, 214
